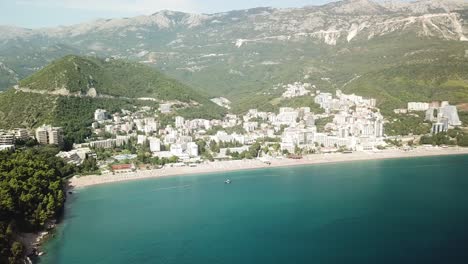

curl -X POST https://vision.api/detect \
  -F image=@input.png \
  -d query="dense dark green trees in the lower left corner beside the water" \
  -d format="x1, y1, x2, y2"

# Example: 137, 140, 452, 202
0, 146, 77, 264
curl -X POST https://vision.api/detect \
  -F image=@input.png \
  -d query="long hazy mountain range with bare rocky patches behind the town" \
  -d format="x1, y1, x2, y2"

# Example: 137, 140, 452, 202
0, 0, 468, 111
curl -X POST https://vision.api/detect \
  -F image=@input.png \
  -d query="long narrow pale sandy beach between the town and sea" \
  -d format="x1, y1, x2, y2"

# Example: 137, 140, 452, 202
69, 147, 468, 188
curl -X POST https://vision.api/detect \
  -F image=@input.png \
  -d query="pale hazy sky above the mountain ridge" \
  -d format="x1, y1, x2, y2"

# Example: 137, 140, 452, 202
0, 0, 333, 28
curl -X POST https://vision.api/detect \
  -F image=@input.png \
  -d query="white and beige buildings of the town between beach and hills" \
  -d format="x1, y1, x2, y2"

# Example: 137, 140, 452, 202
0, 85, 462, 178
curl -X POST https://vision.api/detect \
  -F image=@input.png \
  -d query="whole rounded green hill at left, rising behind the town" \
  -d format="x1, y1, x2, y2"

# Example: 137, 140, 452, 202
0, 55, 225, 143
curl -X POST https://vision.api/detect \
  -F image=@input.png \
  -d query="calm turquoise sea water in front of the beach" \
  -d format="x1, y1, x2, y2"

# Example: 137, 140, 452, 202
41, 156, 468, 264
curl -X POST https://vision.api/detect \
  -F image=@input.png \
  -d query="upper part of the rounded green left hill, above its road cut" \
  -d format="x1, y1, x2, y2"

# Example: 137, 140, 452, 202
17, 55, 214, 104
